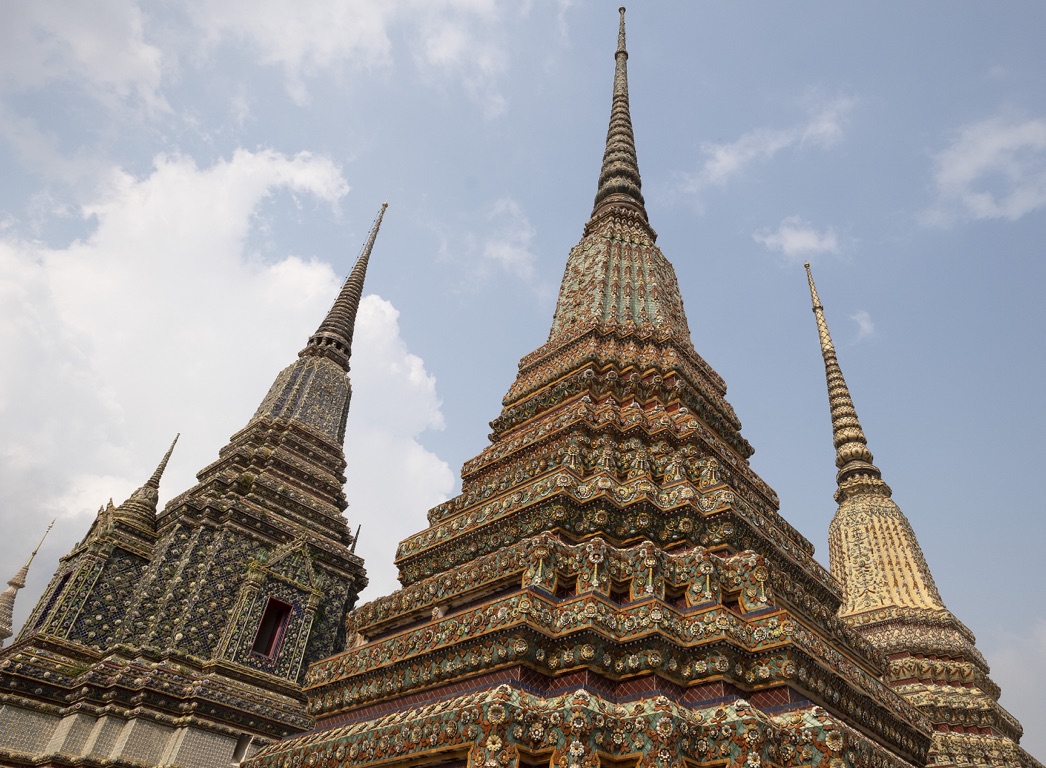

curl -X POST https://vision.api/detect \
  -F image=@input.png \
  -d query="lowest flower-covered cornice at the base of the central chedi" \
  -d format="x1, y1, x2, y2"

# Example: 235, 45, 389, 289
255, 685, 926, 768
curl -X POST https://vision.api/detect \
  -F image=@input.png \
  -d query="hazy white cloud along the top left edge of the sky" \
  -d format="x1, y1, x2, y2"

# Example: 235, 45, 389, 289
0, 0, 516, 117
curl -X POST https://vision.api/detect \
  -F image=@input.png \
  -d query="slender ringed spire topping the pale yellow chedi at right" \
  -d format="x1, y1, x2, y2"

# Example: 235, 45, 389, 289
803, 263, 889, 501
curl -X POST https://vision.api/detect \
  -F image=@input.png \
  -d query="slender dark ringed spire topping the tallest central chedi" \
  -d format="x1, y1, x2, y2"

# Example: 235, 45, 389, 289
589, 7, 649, 225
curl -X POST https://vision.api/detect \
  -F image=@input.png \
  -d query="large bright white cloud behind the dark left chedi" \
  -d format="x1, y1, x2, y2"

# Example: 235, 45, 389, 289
0, 150, 452, 631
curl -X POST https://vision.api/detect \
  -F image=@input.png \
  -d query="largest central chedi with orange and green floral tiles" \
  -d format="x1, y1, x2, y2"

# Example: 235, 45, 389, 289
251, 9, 953, 768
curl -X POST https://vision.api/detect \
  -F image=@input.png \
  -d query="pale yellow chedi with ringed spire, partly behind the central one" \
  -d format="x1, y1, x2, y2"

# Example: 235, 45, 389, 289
805, 264, 1041, 768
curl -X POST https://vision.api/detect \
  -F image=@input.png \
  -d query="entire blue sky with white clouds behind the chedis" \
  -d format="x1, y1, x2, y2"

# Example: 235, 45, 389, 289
0, 0, 1046, 758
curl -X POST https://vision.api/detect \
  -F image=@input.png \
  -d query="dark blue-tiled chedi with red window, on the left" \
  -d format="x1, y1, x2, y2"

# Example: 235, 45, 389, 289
0, 205, 385, 768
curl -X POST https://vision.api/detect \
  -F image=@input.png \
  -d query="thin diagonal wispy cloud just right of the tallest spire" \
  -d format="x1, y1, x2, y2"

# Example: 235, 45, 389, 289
684, 97, 857, 191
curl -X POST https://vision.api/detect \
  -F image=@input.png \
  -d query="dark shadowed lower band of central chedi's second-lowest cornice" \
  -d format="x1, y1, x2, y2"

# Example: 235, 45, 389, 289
308, 627, 932, 751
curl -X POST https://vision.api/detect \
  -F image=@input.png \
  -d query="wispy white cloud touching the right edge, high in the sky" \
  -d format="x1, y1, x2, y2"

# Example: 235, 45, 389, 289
924, 117, 1046, 226
